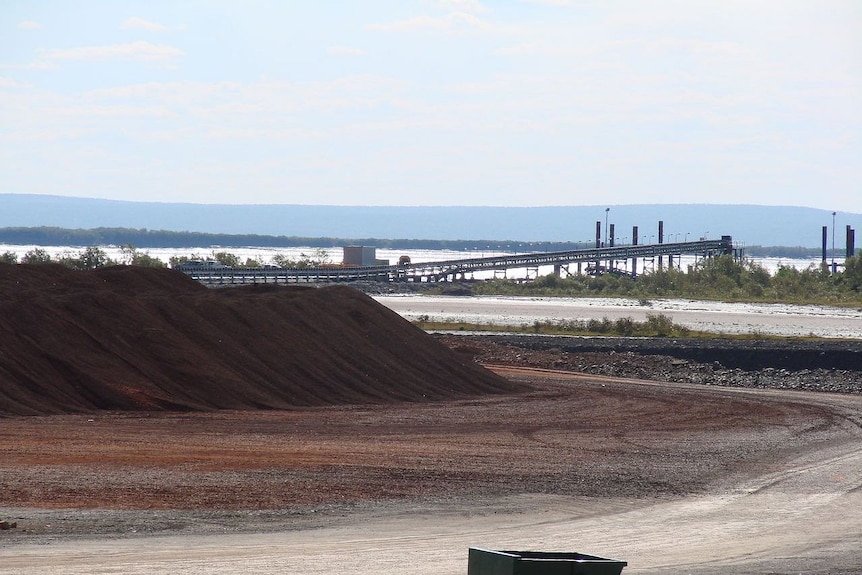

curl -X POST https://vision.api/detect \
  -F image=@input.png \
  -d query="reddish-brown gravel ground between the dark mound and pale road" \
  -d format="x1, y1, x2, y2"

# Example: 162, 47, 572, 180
0, 364, 837, 537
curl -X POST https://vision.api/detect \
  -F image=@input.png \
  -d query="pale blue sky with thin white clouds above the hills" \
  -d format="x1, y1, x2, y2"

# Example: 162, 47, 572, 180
0, 0, 862, 213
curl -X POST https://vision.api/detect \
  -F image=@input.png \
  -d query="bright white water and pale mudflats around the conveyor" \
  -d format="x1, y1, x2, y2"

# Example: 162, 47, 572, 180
5, 245, 862, 339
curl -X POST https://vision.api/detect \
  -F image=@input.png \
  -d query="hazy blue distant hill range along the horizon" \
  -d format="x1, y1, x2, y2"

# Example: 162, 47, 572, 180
0, 194, 862, 250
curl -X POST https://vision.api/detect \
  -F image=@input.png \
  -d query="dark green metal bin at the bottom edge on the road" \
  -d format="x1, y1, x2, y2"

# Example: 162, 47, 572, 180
467, 547, 628, 575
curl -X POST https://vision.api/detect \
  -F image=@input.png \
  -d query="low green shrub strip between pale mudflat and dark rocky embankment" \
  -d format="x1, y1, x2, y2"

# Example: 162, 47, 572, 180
413, 314, 707, 337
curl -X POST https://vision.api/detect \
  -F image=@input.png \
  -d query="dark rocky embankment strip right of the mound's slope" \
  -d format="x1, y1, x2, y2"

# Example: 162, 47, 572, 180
437, 335, 862, 394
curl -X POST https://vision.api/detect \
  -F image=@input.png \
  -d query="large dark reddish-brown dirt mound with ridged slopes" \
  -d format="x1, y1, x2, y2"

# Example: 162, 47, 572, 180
0, 265, 516, 415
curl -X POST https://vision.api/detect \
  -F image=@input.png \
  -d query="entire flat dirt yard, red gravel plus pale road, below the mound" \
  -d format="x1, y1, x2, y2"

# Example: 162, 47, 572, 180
0, 368, 862, 575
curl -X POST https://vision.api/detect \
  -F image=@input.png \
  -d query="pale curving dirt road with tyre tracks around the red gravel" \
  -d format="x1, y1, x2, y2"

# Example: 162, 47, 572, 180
0, 367, 862, 575
